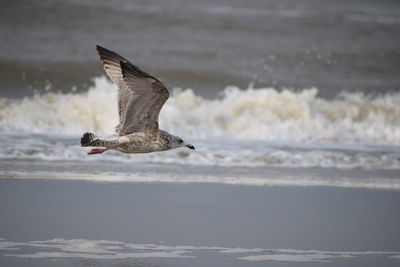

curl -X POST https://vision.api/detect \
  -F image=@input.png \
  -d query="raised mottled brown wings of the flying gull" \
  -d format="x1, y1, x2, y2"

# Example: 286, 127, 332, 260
96, 45, 169, 135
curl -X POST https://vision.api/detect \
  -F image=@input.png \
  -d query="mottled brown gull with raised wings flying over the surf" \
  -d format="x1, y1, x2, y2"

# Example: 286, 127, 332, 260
81, 45, 194, 155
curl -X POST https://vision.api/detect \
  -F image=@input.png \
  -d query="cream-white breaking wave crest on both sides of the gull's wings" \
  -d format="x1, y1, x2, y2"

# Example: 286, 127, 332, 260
0, 77, 400, 144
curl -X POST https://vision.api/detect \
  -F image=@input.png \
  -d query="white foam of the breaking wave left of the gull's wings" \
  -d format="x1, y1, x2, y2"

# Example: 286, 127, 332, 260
0, 78, 117, 134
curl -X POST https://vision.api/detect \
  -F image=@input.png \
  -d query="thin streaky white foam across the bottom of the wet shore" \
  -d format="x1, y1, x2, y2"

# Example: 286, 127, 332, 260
0, 238, 400, 263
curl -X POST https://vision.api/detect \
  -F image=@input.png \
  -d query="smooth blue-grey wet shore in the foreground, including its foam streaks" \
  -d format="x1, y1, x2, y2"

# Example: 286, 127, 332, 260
0, 179, 400, 266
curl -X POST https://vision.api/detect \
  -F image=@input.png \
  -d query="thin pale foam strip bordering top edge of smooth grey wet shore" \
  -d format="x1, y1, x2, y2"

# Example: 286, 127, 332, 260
0, 171, 400, 190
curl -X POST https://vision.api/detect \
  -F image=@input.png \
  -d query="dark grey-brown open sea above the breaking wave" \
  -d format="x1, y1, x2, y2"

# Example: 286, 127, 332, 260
0, 0, 400, 98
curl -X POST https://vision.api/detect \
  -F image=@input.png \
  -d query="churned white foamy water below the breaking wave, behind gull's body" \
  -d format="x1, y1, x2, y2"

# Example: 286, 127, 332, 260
0, 135, 400, 169
